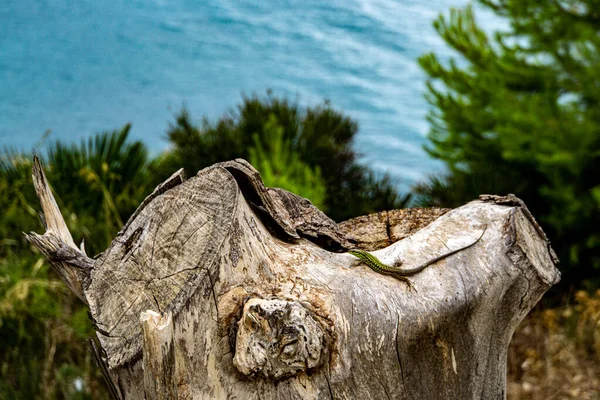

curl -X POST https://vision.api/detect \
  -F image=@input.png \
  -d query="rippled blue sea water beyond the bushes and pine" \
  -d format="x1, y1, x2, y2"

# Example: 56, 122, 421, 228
0, 0, 502, 188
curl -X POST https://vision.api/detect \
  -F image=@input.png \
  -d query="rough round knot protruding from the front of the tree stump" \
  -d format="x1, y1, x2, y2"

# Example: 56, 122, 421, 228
233, 299, 327, 379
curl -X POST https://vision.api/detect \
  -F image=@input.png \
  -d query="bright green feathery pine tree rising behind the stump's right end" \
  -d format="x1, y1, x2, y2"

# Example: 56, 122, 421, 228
416, 0, 600, 284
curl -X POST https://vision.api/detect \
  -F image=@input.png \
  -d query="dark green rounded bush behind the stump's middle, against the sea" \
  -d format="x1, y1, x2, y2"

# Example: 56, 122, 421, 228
163, 94, 408, 221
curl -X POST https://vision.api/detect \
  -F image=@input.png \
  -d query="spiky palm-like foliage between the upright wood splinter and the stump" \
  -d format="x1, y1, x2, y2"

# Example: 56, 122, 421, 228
47, 124, 160, 253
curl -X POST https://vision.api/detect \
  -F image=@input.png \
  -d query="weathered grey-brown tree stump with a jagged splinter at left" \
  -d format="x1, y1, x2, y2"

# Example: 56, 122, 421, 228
28, 160, 559, 400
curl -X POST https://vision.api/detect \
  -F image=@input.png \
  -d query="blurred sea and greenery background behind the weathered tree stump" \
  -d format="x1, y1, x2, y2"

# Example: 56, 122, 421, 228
0, 0, 600, 399
